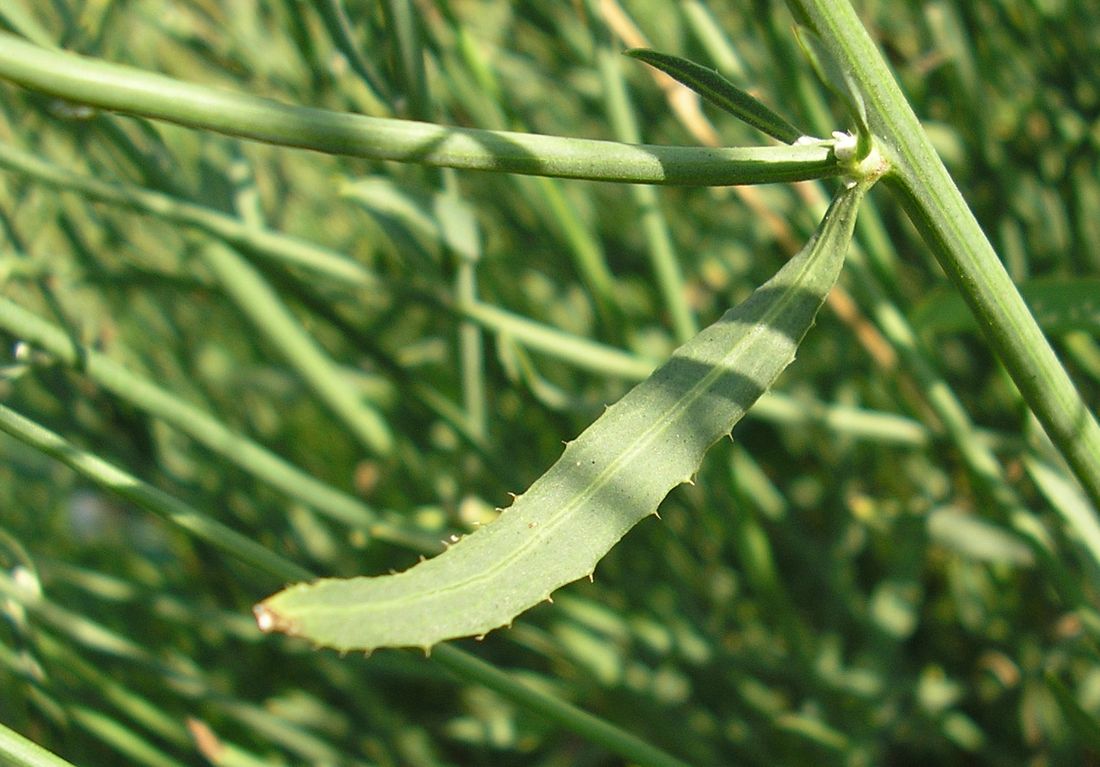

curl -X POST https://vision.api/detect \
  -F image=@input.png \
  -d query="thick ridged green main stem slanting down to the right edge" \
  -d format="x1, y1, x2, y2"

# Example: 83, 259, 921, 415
788, 0, 1100, 508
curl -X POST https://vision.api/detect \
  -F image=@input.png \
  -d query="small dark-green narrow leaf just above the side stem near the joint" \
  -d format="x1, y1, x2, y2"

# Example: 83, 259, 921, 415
626, 48, 805, 144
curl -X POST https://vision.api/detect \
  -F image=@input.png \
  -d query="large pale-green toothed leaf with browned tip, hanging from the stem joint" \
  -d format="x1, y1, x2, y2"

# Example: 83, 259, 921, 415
255, 182, 871, 650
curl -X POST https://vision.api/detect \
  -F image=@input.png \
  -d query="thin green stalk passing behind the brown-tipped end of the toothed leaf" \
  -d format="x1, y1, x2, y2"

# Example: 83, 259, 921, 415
0, 405, 685, 767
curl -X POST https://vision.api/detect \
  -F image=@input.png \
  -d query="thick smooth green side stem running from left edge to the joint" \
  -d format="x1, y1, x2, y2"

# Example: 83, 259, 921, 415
0, 33, 840, 186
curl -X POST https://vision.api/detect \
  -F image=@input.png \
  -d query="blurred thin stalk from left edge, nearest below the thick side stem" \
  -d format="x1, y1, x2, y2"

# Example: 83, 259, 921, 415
0, 142, 381, 288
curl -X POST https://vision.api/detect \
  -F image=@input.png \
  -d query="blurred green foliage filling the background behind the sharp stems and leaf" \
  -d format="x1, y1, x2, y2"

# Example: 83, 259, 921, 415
0, 0, 1100, 767
